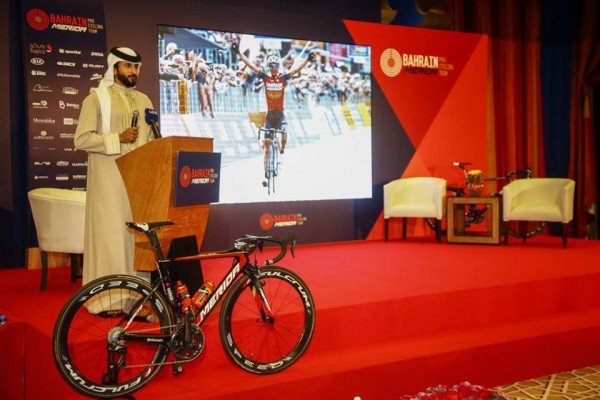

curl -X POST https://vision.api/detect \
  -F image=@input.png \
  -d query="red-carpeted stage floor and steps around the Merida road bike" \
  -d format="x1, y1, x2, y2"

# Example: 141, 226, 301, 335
0, 237, 600, 400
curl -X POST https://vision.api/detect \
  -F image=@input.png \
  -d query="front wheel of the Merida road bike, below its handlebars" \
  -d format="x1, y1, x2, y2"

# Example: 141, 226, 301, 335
220, 267, 315, 375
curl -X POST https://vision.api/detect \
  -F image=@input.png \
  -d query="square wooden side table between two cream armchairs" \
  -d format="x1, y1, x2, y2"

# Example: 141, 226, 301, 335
447, 196, 501, 244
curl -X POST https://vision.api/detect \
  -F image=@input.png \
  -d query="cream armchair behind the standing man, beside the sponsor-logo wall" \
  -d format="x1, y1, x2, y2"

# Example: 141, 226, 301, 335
27, 188, 86, 290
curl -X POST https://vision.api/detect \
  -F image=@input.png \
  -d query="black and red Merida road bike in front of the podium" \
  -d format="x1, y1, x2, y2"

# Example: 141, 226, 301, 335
52, 222, 315, 399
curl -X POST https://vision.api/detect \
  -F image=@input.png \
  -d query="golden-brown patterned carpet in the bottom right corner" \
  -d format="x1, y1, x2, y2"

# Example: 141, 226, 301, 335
495, 365, 600, 400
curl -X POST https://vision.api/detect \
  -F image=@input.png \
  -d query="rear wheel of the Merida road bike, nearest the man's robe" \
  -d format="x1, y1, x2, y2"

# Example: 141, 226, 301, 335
52, 275, 173, 399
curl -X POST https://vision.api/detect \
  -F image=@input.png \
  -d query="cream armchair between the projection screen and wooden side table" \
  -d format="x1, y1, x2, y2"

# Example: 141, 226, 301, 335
383, 177, 446, 242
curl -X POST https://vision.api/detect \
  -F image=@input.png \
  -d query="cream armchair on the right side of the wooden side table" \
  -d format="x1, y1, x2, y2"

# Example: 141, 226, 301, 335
502, 178, 575, 247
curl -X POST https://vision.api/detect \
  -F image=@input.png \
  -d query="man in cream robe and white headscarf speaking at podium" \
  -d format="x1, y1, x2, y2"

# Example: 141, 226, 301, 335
75, 47, 152, 284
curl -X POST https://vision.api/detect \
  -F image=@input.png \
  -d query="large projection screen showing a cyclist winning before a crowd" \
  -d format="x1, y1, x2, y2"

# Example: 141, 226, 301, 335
158, 25, 372, 203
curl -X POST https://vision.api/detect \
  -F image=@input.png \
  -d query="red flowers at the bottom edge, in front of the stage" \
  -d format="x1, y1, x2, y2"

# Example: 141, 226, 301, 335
400, 382, 509, 400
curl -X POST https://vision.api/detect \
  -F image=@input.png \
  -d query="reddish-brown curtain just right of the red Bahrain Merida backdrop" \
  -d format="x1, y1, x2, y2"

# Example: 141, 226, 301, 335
449, 0, 546, 184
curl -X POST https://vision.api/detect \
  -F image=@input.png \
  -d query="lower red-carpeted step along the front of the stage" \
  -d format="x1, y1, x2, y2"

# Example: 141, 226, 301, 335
131, 307, 600, 400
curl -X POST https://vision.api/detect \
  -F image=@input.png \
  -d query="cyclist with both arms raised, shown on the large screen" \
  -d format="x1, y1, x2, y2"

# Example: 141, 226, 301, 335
231, 43, 318, 170
